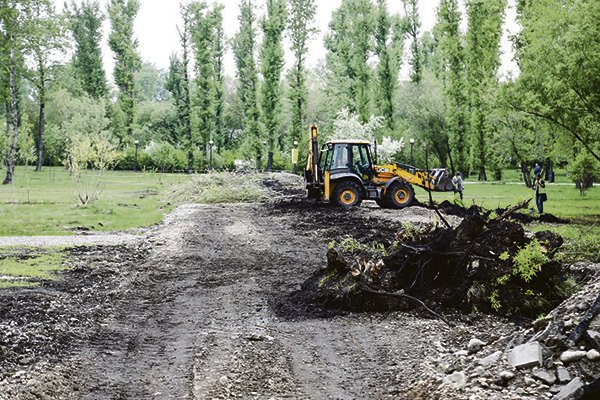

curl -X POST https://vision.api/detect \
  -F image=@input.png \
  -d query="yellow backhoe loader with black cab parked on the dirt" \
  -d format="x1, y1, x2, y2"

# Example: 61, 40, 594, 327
304, 125, 456, 208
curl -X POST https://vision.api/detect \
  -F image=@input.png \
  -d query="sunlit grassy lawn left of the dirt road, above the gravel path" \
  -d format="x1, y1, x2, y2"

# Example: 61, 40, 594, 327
0, 167, 190, 236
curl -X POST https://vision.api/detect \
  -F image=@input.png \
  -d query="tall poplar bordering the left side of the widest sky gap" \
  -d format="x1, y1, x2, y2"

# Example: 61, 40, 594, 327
108, 0, 142, 138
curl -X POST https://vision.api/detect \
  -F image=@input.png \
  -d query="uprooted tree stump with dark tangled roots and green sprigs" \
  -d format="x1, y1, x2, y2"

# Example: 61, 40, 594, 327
303, 209, 570, 317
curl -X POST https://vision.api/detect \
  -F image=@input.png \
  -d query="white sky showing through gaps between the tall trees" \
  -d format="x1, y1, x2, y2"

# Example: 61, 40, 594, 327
53, 0, 517, 81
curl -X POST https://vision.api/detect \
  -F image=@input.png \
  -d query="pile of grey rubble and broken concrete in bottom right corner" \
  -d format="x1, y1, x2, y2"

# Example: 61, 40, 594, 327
415, 265, 600, 400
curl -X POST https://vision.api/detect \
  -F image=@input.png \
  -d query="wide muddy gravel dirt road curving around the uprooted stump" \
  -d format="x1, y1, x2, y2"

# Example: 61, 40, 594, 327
0, 195, 516, 399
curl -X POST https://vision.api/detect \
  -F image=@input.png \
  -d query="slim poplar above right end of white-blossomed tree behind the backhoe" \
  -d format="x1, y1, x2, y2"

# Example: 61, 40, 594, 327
375, 0, 404, 131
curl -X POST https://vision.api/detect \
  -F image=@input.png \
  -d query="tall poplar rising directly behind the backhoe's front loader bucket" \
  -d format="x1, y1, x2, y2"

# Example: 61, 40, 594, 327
434, 0, 469, 174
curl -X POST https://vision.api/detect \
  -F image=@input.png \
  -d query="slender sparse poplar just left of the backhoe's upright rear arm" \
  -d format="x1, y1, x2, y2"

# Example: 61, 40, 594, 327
287, 0, 317, 142
